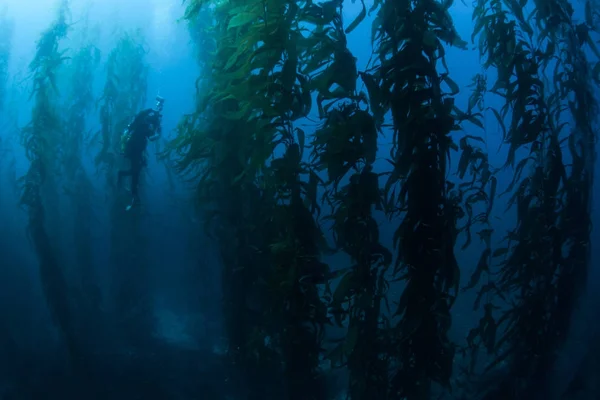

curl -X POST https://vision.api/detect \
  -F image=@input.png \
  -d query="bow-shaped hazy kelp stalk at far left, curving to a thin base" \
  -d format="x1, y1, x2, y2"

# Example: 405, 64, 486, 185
21, 3, 79, 367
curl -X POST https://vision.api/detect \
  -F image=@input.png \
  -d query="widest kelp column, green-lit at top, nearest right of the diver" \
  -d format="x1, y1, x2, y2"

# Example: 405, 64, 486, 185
174, 1, 327, 399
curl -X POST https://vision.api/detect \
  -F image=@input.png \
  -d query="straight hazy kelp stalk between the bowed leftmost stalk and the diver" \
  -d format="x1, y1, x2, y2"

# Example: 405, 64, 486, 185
63, 22, 100, 340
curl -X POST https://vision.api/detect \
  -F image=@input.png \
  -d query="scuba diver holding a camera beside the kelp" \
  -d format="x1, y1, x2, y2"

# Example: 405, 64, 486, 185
117, 96, 165, 211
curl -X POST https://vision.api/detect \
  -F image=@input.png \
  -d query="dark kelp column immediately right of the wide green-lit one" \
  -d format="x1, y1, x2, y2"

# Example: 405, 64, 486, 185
300, 1, 392, 400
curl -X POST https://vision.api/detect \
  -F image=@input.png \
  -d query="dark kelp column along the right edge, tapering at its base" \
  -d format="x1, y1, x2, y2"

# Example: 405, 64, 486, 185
552, 0, 600, 350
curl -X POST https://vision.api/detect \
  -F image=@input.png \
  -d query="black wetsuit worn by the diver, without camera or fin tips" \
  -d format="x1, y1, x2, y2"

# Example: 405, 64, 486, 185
119, 108, 162, 204
